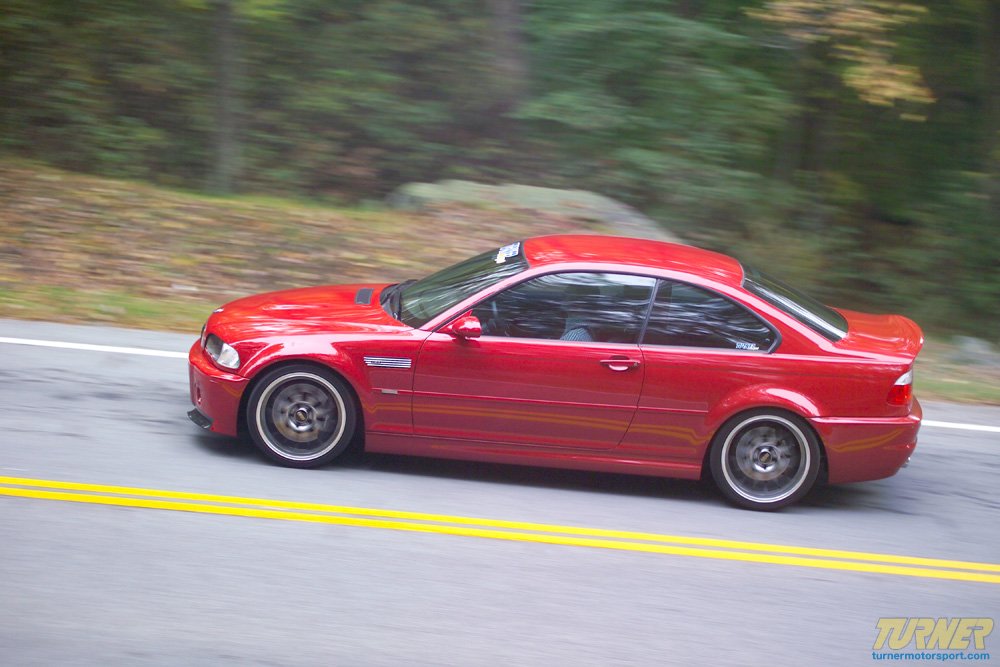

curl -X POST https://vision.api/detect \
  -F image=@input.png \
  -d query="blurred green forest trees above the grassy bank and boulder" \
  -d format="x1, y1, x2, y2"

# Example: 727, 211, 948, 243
0, 0, 1000, 337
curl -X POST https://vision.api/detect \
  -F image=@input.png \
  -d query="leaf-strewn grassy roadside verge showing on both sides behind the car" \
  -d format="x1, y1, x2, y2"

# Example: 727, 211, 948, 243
0, 159, 1000, 405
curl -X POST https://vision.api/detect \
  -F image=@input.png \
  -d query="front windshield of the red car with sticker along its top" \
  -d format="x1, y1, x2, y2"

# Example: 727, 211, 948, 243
399, 243, 528, 328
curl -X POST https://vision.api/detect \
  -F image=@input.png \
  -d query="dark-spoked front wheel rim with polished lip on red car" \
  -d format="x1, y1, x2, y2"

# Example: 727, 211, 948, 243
256, 372, 346, 461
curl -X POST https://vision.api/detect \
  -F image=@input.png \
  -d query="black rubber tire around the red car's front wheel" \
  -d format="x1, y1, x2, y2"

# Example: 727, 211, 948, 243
246, 364, 357, 468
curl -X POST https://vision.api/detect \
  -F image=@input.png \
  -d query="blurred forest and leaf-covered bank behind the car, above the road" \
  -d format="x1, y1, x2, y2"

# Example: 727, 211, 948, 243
0, 0, 1000, 349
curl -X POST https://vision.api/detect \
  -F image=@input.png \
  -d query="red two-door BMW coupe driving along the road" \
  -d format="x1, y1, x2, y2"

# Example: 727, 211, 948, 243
189, 236, 923, 510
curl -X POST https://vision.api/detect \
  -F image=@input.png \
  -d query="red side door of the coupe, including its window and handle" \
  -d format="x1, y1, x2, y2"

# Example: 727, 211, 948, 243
413, 272, 655, 449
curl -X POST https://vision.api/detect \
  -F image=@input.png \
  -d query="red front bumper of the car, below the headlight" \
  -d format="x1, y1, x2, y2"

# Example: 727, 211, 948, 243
188, 341, 249, 436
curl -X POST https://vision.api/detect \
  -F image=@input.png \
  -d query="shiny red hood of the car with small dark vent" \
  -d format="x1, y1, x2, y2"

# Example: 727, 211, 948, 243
208, 283, 404, 341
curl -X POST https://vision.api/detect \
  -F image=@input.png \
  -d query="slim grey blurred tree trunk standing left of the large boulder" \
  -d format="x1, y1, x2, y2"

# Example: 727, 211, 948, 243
211, 0, 240, 194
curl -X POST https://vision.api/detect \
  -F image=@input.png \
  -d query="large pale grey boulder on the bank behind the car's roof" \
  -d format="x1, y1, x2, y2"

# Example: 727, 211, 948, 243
386, 180, 680, 243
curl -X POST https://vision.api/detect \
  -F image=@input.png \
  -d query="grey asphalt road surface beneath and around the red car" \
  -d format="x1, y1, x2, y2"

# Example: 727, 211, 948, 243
0, 321, 1000, 667
